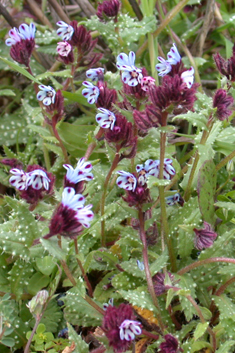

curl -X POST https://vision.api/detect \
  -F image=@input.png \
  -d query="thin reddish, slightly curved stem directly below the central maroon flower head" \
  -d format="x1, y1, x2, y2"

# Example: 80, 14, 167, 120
100, 148, 120, 247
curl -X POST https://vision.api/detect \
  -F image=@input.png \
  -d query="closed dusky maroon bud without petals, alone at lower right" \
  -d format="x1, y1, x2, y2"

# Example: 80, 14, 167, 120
193, 222, 217, 250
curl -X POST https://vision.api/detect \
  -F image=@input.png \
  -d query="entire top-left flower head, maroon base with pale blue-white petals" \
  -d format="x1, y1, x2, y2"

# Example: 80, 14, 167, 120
5, 23, 36, 67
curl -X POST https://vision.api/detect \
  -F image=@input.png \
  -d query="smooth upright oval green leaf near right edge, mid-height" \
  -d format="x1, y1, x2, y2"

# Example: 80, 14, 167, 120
197, 160, 216, 224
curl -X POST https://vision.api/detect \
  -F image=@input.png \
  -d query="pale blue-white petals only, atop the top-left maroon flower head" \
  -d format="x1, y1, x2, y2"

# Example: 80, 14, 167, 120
5, 23, 36, 46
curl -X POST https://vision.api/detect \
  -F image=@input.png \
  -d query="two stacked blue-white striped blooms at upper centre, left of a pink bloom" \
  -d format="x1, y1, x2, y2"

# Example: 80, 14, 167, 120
116, 51, 143, 87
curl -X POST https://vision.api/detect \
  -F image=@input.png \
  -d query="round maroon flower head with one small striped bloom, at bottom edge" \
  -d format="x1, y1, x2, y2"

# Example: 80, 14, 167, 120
102, 304, 142, 353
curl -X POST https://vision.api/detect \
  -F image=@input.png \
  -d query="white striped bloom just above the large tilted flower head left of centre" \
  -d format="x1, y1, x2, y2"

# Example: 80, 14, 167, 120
63, 158, 94, 184
